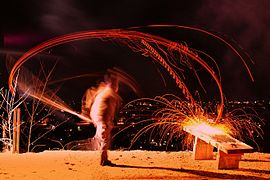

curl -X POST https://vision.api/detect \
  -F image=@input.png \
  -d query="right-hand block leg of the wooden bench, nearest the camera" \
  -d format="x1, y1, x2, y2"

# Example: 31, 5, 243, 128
217, 150, 242, 169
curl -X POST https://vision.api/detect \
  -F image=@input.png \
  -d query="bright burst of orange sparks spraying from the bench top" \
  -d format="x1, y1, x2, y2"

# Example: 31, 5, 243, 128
121, 94, 263, 148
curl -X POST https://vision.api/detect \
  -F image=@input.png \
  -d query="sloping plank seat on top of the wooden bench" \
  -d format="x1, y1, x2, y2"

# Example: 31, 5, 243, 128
183, 126, 253, 154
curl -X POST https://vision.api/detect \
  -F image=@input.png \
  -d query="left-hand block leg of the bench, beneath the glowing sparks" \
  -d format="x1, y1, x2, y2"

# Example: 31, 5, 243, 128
193, 137, 214, 160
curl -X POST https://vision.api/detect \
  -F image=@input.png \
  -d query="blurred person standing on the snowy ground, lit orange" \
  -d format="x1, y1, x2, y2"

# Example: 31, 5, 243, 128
82, 74, 121, 166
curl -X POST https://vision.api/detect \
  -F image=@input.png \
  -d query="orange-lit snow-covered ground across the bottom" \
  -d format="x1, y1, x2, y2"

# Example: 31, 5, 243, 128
0, 151, 270, 180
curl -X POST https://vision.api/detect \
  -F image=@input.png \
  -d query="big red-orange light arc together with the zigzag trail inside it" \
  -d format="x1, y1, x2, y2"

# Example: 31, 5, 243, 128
8, 26, 237, 121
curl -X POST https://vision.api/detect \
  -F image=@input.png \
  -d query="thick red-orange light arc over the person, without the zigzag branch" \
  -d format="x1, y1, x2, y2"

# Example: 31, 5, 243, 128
8, 29, 224, 120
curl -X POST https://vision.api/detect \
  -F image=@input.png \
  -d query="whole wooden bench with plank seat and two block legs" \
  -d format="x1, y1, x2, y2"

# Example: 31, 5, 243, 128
183, 126, 253, 169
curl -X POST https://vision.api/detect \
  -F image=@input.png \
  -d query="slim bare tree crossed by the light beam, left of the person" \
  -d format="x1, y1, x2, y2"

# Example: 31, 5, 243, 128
19, 61, 61, 152
